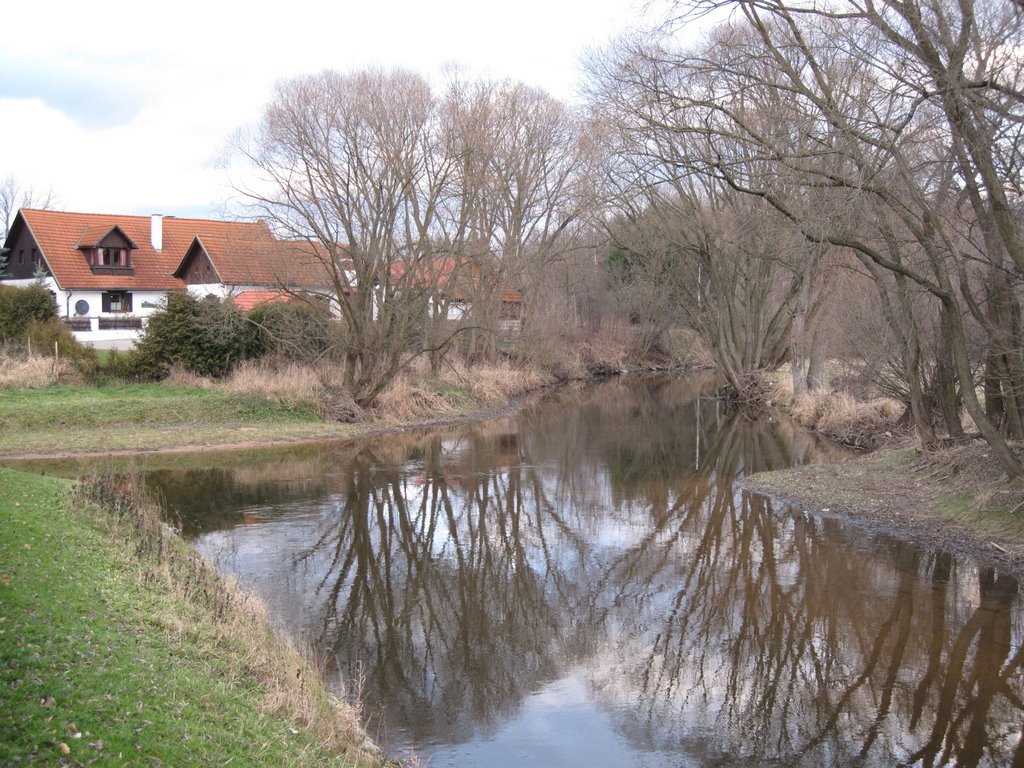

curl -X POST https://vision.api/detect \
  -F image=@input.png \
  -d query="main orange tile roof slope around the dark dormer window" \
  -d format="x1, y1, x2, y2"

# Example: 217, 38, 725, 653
22, 208, 272, 291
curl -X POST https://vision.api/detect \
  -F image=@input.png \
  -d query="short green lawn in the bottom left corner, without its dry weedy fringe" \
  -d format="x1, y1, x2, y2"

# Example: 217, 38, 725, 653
0, 469, 380, 766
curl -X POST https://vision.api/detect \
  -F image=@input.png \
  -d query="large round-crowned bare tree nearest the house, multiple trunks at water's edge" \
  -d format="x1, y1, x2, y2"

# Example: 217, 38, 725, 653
239, 71, 451, 404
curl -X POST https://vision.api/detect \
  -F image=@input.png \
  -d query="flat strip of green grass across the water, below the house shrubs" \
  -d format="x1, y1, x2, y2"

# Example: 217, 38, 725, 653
0, 384, 353, 457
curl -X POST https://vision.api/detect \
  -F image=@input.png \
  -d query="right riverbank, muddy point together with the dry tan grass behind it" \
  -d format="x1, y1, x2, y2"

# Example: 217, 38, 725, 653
743, 377, 1024, 575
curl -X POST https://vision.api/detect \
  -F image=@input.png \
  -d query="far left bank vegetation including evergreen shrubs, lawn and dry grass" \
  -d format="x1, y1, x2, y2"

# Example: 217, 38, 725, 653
0, 286, 692, 457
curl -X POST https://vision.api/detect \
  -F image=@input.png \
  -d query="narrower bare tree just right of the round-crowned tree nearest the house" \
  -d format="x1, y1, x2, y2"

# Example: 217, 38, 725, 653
445, 81, 590, 361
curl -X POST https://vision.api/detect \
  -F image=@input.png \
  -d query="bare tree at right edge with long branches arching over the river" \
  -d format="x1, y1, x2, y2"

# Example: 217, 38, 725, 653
593, 0, 1024, 476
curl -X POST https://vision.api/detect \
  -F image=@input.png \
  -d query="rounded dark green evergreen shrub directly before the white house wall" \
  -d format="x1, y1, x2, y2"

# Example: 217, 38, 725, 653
131, 293, 251, 380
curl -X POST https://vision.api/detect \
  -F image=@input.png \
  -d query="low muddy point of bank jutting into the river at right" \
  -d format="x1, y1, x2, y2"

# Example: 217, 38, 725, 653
743, 441, 1024, 577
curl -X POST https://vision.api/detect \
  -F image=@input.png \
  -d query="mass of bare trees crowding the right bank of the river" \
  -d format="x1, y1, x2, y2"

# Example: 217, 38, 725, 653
591, 0, 1024, 476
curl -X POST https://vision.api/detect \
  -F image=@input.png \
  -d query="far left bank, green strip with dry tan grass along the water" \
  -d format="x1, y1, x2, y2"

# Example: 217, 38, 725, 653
0, 366, 552, 459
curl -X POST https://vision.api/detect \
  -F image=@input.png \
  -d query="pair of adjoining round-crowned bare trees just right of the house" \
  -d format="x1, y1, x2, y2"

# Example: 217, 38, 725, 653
238, 71, 585, 404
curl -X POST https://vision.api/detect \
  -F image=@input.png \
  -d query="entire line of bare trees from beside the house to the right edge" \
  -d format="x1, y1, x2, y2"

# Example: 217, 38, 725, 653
226, 0, 1024, 476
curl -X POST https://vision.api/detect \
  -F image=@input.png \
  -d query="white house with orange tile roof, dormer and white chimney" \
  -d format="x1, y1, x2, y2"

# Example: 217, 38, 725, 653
0, 208, 342, 349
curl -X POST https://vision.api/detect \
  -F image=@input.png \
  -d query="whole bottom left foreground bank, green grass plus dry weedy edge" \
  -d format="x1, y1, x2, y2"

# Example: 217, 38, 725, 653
0, 469, 376, 766
